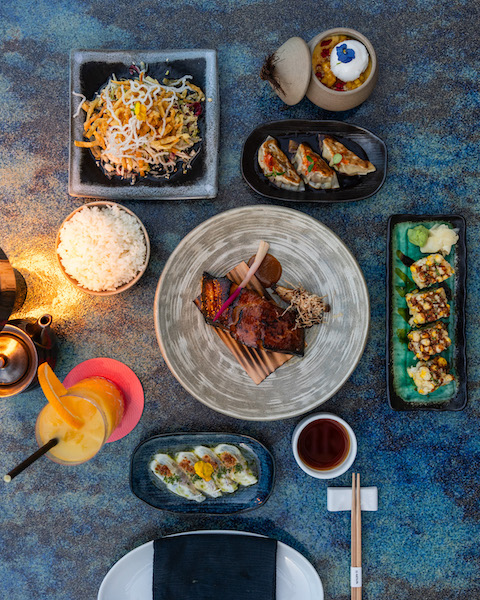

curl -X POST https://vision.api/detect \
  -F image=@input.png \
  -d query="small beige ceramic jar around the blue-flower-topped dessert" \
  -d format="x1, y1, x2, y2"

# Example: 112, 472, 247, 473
307, 27, 378, 111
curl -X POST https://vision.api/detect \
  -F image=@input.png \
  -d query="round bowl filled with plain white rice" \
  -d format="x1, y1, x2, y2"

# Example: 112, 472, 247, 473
56, 201, 150, 296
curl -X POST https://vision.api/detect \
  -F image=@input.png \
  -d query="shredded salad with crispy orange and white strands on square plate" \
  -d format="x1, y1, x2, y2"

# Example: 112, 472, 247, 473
75, 65, 205, 183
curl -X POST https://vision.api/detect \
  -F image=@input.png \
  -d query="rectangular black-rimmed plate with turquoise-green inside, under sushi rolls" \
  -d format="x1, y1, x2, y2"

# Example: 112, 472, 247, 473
386, 215, 467, 410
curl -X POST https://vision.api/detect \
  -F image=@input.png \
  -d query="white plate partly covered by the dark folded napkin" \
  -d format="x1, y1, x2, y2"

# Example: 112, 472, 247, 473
98, 530, 323, 600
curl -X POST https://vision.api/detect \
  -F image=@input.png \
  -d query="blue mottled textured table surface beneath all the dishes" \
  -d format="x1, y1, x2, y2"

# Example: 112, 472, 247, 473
0, 0, 480, 600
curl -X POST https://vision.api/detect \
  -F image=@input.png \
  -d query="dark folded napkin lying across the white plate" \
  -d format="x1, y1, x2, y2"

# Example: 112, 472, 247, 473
153, 533, 277, 600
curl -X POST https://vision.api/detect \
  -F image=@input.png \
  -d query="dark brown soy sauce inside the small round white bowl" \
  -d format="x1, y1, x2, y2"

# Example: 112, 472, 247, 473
297, 419, 350, 471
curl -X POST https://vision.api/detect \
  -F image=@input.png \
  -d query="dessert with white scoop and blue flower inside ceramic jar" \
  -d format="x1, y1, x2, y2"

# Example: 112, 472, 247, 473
312, 35, 372, 92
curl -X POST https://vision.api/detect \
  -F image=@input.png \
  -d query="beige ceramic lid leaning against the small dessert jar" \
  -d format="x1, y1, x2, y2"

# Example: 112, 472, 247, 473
267, 37, 312, 106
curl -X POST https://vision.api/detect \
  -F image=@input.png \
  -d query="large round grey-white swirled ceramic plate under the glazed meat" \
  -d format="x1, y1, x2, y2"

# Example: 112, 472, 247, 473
154, 206, 370, 421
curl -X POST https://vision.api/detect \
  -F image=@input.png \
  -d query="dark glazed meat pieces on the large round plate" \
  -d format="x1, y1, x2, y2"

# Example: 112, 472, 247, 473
200, 272, 305, 356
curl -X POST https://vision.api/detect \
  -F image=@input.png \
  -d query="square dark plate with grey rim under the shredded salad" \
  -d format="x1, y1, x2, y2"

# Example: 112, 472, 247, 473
68, 50, 219, 200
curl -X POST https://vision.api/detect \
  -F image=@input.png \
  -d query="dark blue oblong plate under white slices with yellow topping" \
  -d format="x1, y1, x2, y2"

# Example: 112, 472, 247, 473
130, 433, 275, 514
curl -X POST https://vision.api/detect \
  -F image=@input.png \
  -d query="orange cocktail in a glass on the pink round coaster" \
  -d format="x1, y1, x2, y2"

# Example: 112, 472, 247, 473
35, 377, 124, 465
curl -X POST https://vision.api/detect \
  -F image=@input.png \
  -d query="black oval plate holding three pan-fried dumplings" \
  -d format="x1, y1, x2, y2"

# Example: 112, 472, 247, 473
242, 119, 387, 202
